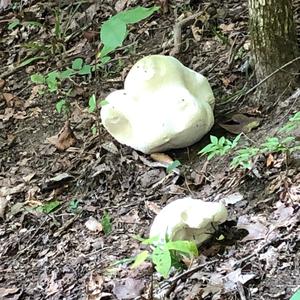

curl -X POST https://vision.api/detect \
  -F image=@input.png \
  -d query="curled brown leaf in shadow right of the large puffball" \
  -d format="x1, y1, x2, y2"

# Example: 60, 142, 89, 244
219, 114, 262, 134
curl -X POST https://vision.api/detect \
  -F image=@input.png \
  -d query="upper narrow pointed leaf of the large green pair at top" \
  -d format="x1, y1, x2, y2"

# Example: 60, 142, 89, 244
115, 6, 159, 24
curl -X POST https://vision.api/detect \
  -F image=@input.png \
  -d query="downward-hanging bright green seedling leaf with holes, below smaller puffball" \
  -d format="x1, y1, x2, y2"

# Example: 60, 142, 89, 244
151, 246, 172, 278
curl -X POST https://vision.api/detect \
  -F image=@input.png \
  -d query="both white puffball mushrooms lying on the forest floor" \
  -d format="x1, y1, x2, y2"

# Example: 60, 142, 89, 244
101, 55, 227, 245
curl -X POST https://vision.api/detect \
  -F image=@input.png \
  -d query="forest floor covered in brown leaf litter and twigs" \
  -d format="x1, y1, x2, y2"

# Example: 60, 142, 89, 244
0, 0, 300, 300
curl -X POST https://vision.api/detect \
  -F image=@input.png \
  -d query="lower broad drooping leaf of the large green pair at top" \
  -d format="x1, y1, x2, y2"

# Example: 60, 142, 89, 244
100, 16, 127, 57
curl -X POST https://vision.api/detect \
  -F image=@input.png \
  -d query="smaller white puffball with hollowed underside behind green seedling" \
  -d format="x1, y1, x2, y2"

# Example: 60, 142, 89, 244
150, 197, 227, 245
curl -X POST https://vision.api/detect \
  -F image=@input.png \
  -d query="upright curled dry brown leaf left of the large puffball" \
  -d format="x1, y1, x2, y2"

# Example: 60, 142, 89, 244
47, 121, 77, 151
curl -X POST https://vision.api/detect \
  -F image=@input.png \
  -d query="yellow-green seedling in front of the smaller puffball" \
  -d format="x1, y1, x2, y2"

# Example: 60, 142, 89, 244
132, 238, 198, 278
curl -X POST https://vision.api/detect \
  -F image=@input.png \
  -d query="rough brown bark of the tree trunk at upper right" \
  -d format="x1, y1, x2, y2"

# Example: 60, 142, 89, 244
248, 0, 298, 101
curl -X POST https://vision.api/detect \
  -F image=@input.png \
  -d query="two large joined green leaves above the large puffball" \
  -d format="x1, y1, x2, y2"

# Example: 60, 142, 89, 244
98, 6, 159, 63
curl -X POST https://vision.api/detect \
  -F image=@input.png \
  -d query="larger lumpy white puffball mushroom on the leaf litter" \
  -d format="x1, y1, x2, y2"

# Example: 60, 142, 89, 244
101, 55, 214, 153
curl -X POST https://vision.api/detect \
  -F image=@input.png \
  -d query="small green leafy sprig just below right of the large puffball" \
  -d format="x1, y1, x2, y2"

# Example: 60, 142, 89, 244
198, 134, 241, 160
